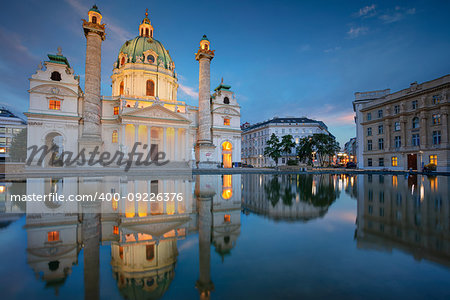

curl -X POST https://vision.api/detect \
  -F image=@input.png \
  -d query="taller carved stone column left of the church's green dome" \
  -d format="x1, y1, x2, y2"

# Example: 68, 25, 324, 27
79, 5, 105, 150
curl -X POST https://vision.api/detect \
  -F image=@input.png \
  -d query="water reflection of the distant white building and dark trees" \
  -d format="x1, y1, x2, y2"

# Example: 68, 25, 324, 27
242, 174, 340, 221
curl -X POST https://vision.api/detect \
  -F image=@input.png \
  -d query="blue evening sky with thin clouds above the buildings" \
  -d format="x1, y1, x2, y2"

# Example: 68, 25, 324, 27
0, 0, 450, 145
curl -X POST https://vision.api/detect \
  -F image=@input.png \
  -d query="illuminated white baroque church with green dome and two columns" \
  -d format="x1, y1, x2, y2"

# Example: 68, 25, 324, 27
25, 5, 241, 168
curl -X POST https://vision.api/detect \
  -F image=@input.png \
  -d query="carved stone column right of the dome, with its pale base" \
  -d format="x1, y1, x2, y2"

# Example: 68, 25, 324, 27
195, 35, 217, 168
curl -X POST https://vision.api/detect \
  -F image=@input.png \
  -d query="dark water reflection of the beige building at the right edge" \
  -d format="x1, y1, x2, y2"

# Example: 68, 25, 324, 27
356, 175, 450, 266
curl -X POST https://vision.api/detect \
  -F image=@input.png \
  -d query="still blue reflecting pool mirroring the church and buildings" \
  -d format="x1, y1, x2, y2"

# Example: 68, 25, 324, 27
0, 174, 450, 300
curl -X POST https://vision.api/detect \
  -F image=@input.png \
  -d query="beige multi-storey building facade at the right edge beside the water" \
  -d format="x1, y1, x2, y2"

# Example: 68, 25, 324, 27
353, 75, 450, 172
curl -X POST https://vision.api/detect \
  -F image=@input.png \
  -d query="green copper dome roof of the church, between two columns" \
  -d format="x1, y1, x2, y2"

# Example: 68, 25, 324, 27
117, 36, 172, 69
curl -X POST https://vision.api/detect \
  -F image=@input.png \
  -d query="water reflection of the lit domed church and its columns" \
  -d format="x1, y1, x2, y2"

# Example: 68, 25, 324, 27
25, 175, 241, 299
